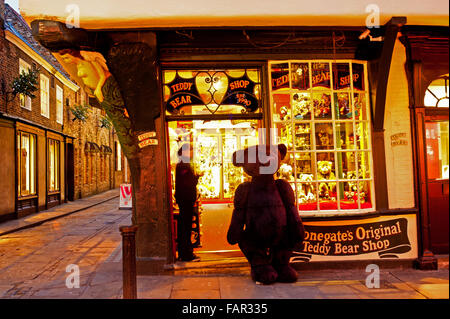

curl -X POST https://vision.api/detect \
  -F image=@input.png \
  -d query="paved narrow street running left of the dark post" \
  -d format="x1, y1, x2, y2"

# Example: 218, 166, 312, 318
0, 198, 131, 298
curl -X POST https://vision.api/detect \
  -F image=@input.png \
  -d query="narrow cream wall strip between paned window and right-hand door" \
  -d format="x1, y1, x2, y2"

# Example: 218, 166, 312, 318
385, 35, 414, 209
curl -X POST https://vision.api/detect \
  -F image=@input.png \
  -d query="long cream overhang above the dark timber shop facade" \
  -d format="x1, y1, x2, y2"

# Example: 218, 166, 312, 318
20, 0, 449, 29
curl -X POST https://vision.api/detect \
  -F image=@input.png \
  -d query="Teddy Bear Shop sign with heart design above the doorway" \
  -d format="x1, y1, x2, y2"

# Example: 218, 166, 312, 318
166, 72, 259, 113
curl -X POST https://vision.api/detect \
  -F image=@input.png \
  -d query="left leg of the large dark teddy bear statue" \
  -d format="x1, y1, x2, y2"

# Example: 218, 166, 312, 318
239, 240, 278, 285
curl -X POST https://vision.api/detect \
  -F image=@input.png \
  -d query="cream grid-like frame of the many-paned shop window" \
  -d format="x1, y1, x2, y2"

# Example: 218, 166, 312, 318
267, 59, 376, 217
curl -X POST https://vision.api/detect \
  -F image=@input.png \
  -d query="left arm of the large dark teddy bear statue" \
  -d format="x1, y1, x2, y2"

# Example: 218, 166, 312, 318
227, 182, 250, 245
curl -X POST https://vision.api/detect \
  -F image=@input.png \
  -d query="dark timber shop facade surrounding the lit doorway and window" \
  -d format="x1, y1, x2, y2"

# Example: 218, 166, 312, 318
29, 17, 449, 273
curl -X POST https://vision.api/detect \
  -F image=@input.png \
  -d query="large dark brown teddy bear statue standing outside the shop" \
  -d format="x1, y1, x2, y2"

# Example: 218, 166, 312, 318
227, 144, 304, 284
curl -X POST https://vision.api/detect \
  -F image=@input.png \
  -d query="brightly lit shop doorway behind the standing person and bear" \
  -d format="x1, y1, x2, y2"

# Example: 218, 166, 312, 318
167, 120, 261, 260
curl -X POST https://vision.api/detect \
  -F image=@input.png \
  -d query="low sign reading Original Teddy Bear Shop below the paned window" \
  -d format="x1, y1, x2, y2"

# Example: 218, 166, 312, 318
292, 217, 416, 261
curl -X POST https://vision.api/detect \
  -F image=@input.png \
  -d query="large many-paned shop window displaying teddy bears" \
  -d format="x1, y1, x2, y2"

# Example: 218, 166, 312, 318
269, 60, 373, 213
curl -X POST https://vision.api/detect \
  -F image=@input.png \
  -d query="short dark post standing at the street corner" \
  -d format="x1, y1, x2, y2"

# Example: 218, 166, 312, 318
119, 226, 137, 299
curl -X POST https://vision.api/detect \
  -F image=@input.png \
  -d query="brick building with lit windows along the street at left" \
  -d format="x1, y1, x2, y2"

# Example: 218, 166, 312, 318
0, 0, 125, 222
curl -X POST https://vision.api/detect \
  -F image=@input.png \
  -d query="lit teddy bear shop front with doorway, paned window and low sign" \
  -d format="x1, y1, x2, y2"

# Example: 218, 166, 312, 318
162, 59, 418, 265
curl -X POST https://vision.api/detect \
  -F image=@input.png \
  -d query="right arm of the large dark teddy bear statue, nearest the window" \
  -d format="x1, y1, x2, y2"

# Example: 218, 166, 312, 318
276, 179, 305, 246
